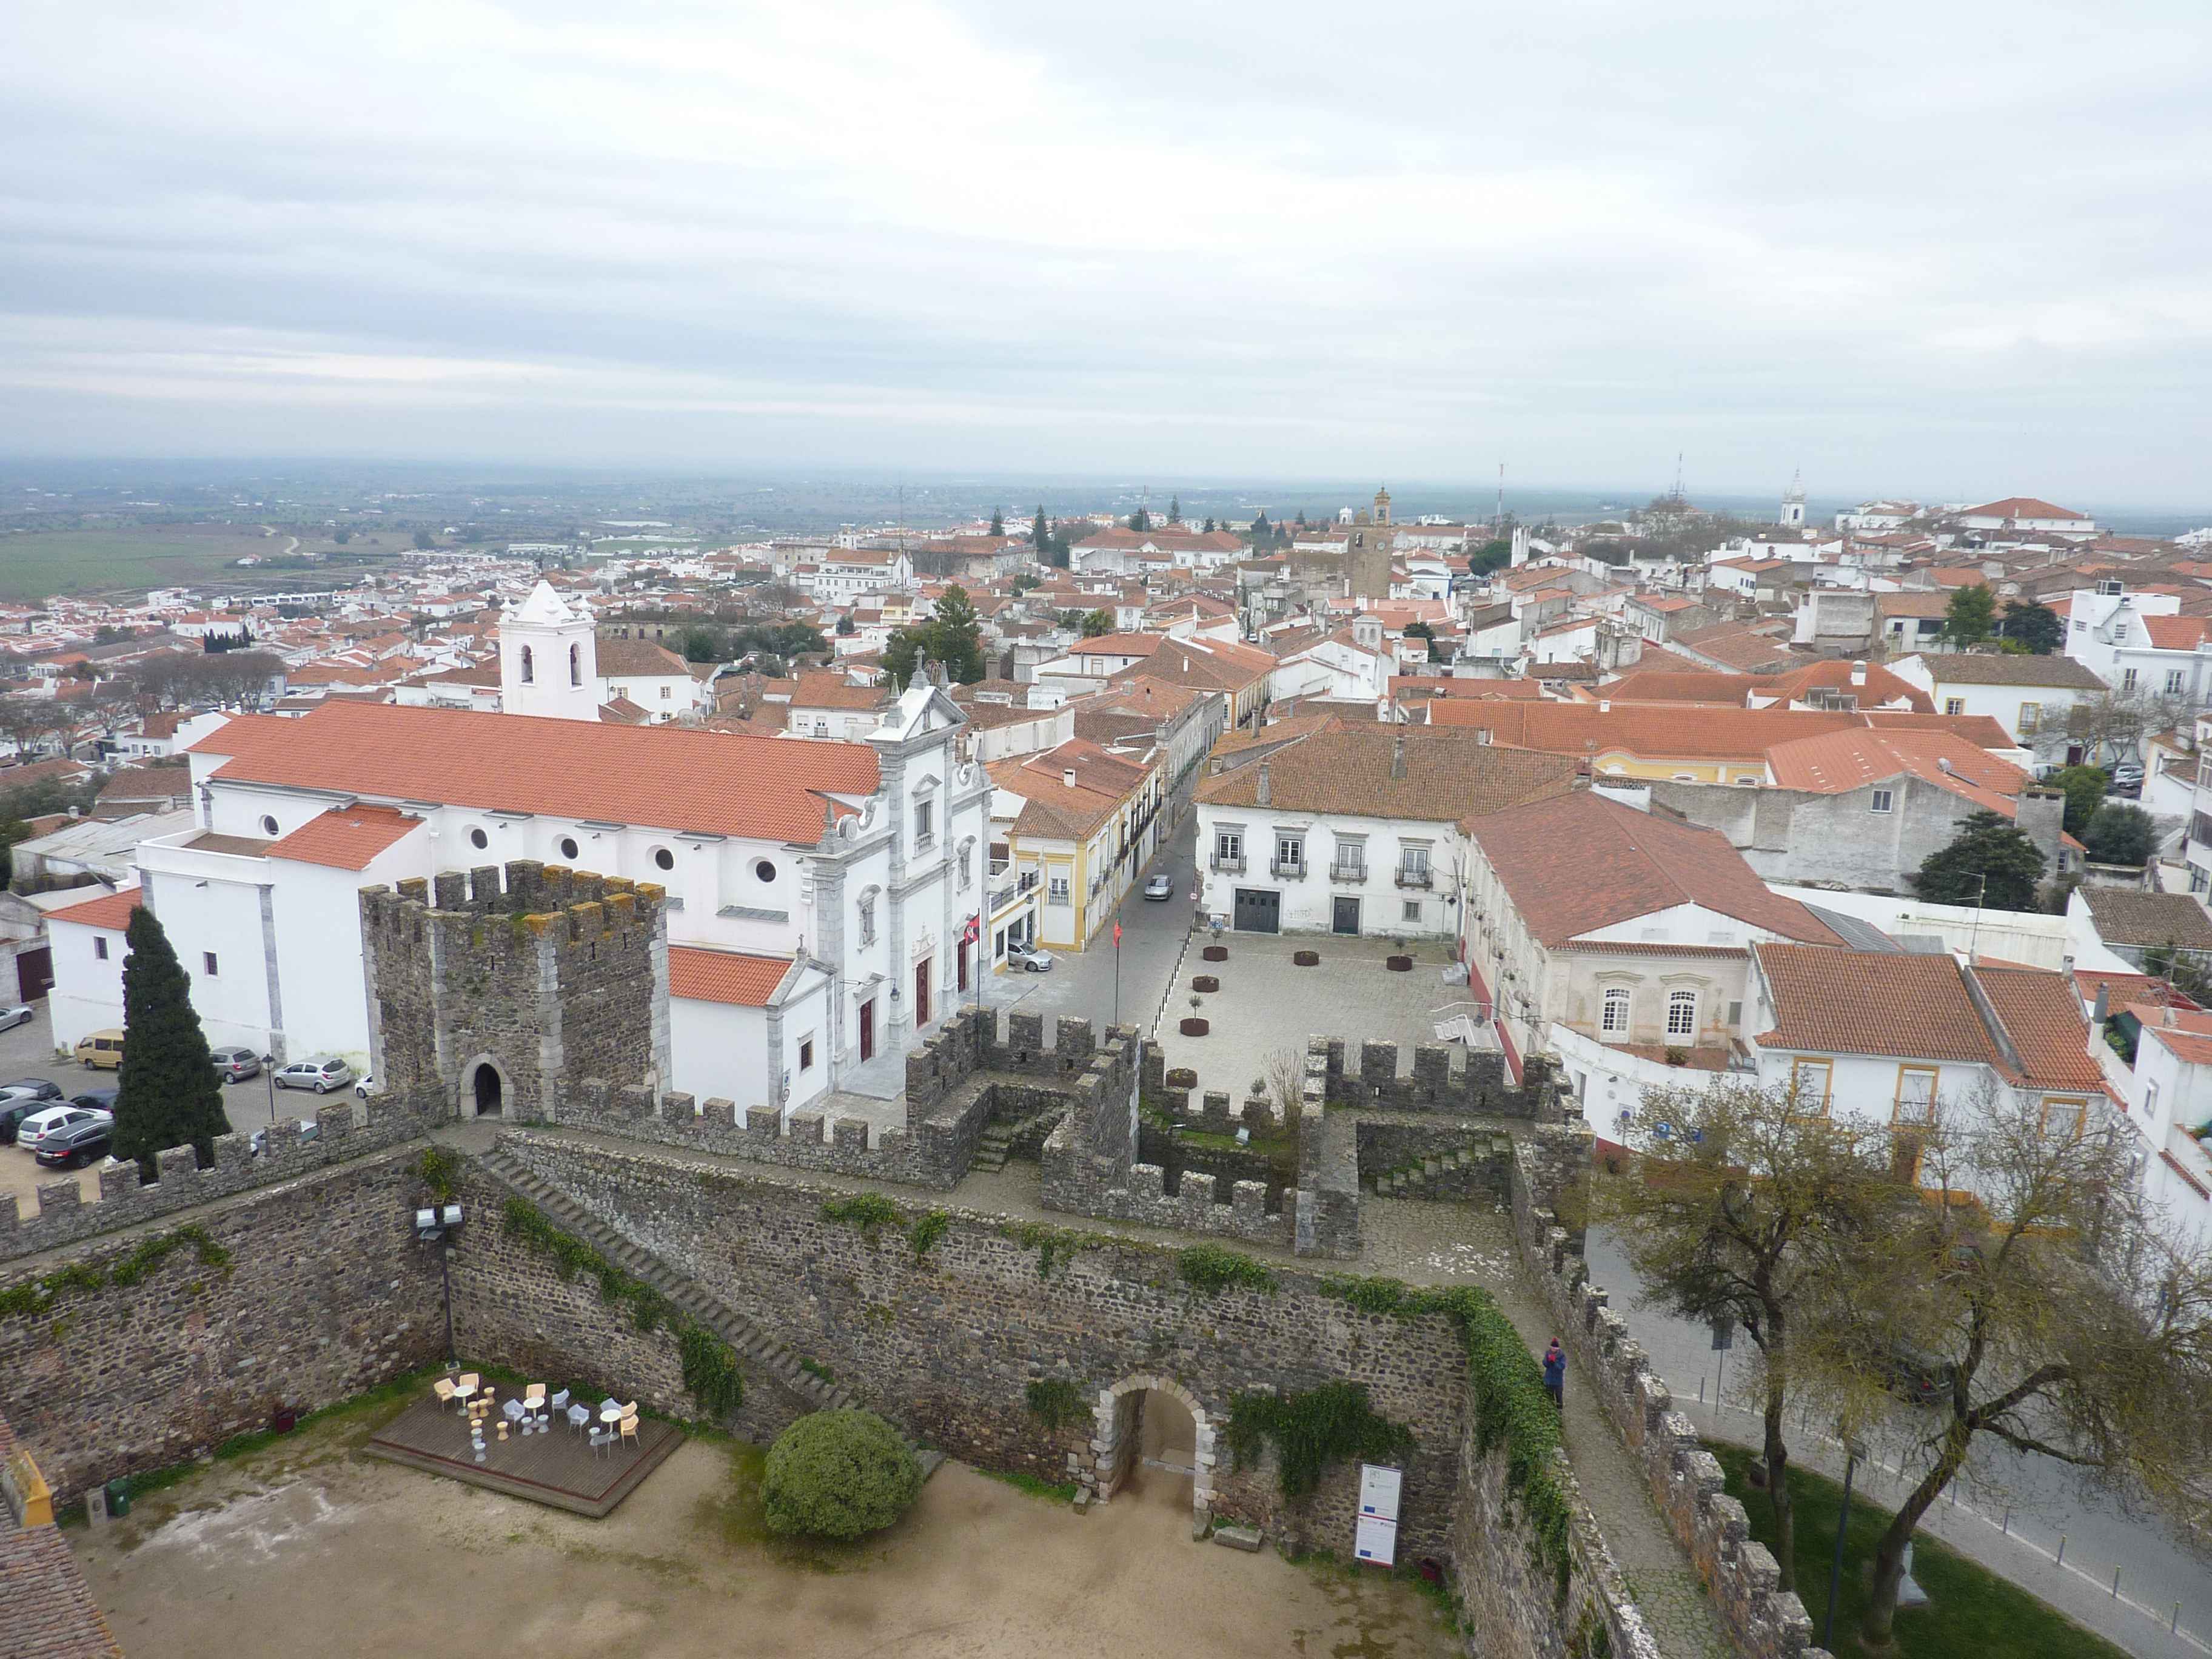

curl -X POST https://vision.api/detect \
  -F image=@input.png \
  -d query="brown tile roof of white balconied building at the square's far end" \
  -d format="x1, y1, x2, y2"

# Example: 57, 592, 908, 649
1199, 729, 1575, 823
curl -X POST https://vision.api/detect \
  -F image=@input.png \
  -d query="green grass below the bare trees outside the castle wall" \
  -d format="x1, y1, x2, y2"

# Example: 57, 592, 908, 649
1708, 1447, 2123, 1659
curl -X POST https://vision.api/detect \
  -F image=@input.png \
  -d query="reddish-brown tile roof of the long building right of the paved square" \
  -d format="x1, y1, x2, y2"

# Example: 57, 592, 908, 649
1467, 789, 1843, 949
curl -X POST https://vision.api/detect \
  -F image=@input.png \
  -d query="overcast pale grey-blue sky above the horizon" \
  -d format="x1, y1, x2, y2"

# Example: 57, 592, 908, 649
0, 0, 2212, 504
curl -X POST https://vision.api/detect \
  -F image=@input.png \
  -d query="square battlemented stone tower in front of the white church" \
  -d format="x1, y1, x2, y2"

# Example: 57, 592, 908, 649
361, 858, 668, 1122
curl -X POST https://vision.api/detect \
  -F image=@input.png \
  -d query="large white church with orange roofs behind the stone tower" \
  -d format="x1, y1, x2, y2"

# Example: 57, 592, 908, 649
49, 681, 989, 1110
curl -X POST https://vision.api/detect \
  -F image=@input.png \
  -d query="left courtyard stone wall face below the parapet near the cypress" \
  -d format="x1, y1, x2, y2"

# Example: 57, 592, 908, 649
0, 1148, 444, 1502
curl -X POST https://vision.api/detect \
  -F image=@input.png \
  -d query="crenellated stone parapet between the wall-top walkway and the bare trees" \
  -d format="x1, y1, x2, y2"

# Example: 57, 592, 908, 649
1513, 1124, 1827, 1659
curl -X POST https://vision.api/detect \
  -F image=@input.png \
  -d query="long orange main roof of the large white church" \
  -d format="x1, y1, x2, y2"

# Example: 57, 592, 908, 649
192, 703, 876, 843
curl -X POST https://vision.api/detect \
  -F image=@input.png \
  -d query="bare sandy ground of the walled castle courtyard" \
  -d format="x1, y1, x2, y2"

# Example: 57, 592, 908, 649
71, 1409, 1453, 1659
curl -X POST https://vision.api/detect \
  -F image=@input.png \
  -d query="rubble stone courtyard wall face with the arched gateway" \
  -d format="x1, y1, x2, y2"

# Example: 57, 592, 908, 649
497, 1130, 1464, 1560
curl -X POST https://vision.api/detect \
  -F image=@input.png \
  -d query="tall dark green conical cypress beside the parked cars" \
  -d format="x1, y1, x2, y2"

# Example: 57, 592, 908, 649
110, 907, 230, 1181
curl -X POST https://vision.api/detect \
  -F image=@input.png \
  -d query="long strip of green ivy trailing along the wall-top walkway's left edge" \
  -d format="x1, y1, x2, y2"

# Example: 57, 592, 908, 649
1321, 1279, 1573, 1595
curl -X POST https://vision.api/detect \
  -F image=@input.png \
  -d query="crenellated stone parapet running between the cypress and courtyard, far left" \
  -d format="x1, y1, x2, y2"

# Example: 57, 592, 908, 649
0, 1097, 424, 1261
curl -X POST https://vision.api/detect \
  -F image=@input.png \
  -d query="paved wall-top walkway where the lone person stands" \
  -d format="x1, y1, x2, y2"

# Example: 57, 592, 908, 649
1361, 1197, 1728, 1659
